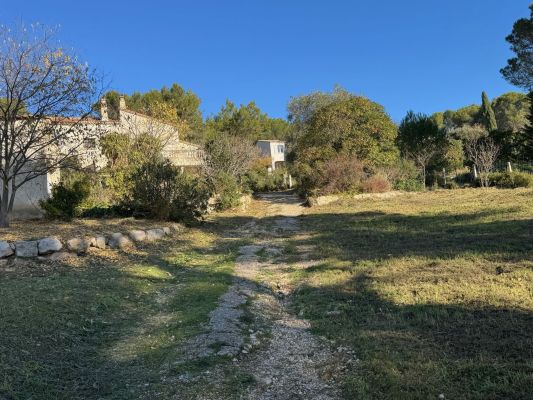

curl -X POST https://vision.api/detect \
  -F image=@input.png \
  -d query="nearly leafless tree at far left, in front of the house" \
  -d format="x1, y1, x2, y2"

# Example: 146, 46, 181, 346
0, 25, 99, 227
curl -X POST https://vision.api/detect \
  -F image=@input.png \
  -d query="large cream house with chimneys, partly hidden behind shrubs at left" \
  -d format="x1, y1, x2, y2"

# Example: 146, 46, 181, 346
13, 97, 204, 218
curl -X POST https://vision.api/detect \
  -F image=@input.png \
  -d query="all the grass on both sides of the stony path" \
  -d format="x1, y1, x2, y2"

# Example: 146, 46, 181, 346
0, 189, 533, 399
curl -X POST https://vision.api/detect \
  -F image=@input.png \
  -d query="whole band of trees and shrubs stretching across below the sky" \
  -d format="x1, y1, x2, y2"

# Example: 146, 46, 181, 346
0, 4, 533, 226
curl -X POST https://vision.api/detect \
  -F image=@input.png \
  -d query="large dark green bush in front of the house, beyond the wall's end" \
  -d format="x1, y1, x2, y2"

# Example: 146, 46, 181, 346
123, 160, 209, 220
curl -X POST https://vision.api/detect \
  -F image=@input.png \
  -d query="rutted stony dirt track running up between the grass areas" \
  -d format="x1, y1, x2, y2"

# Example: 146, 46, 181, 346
184, 193, 349, 400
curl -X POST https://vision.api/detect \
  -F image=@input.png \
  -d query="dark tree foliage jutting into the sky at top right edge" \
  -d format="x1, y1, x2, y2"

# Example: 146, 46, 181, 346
501, 4, 533, 91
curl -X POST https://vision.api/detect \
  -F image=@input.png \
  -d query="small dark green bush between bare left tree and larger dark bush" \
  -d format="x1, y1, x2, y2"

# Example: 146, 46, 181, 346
39, 179, 90, 221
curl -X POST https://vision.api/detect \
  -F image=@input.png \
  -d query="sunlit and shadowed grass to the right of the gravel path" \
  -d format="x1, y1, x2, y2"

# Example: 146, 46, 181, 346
287, 189, 533, 399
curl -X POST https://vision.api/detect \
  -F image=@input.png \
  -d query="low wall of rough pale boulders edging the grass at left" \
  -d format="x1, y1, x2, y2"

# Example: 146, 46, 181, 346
0, 224, 184, 261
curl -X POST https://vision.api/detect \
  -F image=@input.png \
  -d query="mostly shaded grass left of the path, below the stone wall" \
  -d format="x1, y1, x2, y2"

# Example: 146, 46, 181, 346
0, 229, 234, 399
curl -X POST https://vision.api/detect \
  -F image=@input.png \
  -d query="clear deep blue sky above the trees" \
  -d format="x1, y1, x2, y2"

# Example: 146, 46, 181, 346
0, 0, 530, 121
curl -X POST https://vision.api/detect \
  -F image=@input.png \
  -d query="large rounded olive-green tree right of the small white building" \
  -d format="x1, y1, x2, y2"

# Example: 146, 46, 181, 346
289, 88, 398, 192
